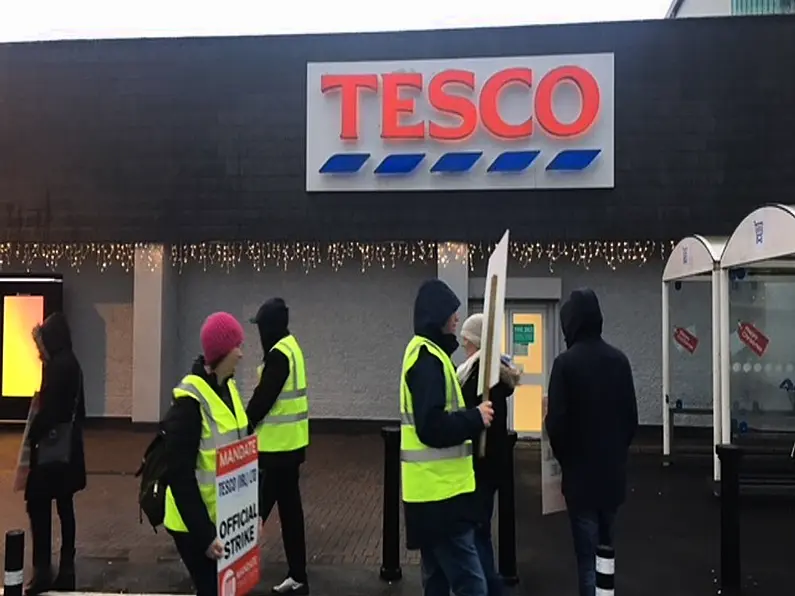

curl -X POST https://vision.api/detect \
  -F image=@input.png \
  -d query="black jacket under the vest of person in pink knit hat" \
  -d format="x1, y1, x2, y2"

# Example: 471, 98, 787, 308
162, 356, 248, 550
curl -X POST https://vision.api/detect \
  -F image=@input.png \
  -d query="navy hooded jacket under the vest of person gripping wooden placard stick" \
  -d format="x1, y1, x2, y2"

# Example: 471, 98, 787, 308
404, 279, 483, 549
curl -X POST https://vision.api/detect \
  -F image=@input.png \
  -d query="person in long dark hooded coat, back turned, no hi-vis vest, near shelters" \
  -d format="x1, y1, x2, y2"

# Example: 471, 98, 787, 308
544, 289, 638, 596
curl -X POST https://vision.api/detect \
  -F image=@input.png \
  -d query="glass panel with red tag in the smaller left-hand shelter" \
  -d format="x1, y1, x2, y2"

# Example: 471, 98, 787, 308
668, 277, 712, 427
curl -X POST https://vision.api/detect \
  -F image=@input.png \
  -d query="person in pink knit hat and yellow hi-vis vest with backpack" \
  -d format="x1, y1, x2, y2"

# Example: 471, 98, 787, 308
163, 312, 260, 596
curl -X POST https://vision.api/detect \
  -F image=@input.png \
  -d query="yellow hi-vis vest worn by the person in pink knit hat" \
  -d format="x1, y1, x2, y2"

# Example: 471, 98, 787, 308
163, 375, 248, 532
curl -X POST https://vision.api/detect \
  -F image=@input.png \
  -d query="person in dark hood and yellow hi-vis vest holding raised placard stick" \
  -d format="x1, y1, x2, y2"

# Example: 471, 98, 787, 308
400, 279, 494, 596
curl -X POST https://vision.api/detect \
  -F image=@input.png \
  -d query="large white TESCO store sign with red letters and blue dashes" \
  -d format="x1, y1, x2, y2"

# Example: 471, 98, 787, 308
306, 54, 614, 192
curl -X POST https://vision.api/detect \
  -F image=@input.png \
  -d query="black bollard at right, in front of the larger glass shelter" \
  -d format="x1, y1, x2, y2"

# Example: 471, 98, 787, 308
715, 445, 743, 594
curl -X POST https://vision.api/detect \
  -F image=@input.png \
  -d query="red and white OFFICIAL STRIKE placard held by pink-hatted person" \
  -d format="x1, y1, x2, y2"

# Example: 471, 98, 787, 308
215, 437, 260, 596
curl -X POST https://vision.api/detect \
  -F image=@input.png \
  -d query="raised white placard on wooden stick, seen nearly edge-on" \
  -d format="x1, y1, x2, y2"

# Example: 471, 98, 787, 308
478, 230, 510, 395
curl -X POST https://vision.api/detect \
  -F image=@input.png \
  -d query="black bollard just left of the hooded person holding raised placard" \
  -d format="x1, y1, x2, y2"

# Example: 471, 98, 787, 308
381, 426, 403, 582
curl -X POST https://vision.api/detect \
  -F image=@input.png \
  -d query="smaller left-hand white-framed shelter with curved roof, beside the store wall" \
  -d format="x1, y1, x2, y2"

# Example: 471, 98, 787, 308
662, 235, 726, 481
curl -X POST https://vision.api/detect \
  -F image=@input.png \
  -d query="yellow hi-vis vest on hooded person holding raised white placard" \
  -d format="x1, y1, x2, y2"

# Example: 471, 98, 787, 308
400, 337, 475, 503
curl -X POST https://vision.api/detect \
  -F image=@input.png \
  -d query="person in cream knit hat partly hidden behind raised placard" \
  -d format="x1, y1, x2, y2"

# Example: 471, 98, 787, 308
457, 314, 521, 596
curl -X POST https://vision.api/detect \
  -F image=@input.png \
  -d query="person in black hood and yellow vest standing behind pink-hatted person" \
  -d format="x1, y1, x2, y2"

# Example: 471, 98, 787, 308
246, 298, 309, 594
